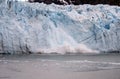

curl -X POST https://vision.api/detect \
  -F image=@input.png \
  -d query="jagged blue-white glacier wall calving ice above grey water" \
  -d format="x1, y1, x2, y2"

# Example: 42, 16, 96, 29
0, 0, 120, 54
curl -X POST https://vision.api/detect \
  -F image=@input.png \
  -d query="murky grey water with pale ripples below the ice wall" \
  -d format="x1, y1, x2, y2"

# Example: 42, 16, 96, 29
0, 54, 120, 79
